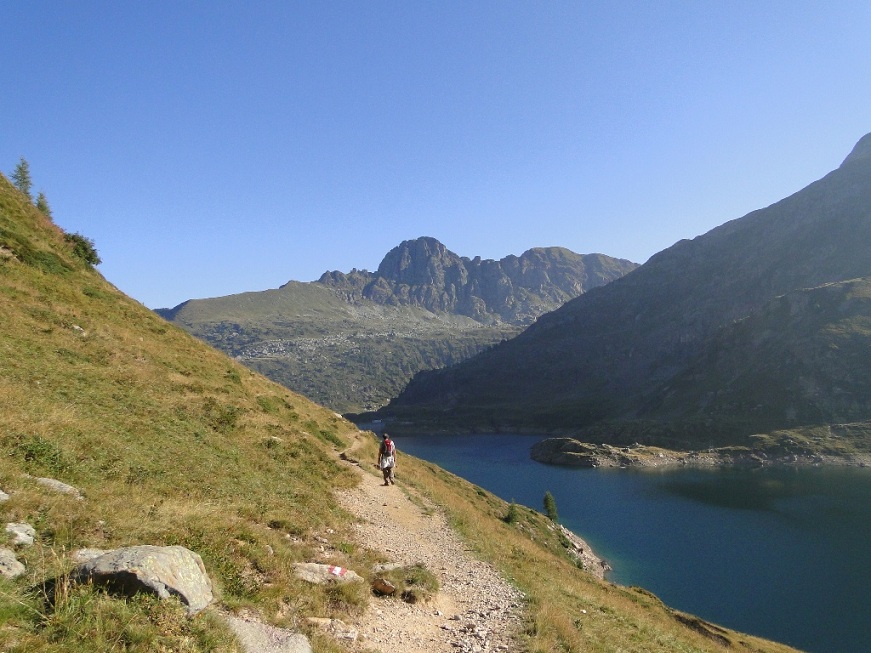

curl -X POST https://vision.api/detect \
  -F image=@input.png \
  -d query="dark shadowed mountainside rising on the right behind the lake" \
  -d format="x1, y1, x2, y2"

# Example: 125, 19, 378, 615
382, 135, 871, 452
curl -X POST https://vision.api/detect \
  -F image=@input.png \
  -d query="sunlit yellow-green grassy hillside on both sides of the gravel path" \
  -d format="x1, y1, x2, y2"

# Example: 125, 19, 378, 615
0, 176, 800, 653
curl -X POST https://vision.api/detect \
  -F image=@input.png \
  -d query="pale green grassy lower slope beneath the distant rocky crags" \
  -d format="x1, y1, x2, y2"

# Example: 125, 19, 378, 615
158, 282, 521, 413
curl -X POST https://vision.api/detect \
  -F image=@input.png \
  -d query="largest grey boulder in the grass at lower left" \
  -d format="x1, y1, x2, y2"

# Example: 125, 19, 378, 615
72, 545, 214, 615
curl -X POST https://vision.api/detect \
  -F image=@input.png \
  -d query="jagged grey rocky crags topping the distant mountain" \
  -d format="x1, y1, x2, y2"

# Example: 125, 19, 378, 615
318, 237, 638, 325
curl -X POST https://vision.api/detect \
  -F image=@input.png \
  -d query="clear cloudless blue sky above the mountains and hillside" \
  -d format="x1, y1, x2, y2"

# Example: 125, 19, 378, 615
0, 0, 871, 308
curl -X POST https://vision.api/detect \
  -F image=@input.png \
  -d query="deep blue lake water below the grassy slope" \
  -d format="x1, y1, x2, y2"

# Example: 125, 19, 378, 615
396, 435, 871, 653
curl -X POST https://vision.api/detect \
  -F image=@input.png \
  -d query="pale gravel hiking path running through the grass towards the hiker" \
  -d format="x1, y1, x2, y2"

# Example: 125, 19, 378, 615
337, 460, 523, 653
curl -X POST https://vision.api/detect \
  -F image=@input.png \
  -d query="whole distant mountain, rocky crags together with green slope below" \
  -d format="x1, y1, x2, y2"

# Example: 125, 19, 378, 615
158, 238, 635, 413
